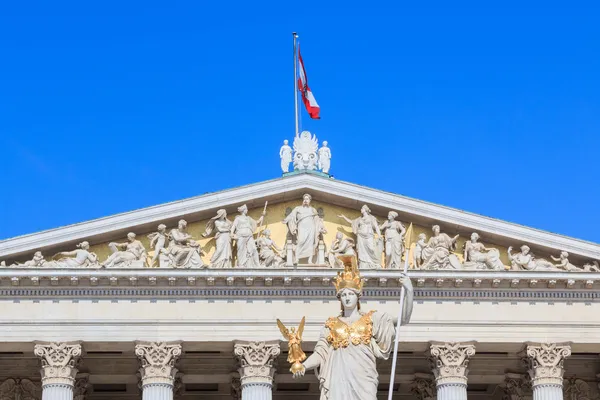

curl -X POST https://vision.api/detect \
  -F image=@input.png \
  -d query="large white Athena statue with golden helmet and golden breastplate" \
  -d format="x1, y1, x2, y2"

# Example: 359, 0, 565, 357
294, 256, 413, 400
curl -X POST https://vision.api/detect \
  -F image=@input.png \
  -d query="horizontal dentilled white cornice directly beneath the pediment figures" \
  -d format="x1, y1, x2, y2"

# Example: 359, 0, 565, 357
0, 268, 600, 301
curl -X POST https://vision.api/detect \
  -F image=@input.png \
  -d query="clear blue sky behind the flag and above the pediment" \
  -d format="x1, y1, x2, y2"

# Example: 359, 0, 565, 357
0, 0, 600, 242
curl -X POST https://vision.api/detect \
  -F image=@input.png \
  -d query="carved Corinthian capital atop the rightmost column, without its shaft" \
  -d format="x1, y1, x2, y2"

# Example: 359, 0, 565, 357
525, 343, 571, 386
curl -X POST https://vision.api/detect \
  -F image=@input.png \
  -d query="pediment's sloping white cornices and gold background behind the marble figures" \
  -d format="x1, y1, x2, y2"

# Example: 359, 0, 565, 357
0, 172, 600, 272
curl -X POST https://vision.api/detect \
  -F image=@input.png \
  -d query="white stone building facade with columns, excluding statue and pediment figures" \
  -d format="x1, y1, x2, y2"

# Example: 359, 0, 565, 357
0, 173, 600, 400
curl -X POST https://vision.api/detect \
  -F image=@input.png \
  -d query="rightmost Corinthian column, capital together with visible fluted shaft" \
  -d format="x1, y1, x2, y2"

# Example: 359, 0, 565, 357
525, 343, 571, 400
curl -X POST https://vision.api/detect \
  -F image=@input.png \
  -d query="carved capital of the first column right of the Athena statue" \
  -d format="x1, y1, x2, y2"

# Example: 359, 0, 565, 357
429, 342, 475, 386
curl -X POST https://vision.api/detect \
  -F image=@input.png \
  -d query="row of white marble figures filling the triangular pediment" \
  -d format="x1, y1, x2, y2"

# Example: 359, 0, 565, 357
0, 197, 600, 273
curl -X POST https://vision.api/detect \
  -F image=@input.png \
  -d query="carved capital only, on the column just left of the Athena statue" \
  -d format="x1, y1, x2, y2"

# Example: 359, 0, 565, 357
233, 340, 281, 386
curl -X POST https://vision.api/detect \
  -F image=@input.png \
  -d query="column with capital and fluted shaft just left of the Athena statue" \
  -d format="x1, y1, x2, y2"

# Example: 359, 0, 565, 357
234, 340, 281, 400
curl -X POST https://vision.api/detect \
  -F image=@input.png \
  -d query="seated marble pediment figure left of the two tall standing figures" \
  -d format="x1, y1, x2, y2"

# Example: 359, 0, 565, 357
162, 219, 205, 268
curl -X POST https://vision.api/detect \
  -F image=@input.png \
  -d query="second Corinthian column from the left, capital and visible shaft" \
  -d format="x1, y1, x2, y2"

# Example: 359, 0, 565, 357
135, 342, 181, 400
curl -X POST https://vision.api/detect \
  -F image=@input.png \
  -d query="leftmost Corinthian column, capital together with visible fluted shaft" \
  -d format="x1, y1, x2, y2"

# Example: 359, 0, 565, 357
33, 342, 81, 400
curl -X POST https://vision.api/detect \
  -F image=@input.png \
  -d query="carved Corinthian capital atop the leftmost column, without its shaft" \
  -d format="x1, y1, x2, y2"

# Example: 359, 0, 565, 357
33, 342, 81, 387
